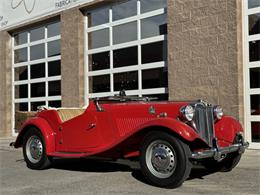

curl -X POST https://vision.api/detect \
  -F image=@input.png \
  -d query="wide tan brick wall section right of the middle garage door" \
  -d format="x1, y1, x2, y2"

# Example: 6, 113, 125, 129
168, 0, 243, 122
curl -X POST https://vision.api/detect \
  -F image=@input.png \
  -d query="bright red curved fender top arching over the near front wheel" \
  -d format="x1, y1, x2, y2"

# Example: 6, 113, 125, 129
139, 118, 199, 142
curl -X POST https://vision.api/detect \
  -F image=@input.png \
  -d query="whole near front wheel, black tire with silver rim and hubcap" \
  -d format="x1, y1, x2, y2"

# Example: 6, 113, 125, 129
140, 131, 192, 188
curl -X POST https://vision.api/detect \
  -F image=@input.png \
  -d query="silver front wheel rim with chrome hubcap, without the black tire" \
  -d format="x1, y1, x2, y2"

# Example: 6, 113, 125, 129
146, 140, 176, 178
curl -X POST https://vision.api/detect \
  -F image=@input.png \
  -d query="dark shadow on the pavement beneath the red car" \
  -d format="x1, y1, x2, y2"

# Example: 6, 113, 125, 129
52, 159, 213, 185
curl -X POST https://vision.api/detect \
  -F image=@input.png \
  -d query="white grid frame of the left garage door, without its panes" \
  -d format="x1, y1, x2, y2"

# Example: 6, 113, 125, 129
11, 21, 62, 136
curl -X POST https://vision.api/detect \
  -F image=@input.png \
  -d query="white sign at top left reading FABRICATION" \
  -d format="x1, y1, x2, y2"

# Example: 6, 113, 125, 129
0, 0, 93, 30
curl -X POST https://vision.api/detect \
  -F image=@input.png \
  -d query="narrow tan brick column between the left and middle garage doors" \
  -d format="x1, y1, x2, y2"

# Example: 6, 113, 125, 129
61, 8, 84, 107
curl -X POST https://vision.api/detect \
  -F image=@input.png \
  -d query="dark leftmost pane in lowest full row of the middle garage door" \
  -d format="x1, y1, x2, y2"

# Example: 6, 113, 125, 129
89, 75, 110, 93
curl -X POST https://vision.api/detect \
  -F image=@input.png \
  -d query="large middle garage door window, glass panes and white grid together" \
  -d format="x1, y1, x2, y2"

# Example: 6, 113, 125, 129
85, 0, 168, 100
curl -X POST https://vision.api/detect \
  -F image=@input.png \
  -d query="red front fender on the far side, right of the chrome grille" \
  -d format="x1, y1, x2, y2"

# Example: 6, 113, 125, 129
215, 116, 244, 143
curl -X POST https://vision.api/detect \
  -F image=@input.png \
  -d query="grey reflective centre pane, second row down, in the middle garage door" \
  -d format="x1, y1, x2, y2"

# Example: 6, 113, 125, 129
113, 22, 137, 44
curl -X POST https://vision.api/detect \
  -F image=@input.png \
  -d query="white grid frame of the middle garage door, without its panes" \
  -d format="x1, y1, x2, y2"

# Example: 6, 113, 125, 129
84, 0, 168, 105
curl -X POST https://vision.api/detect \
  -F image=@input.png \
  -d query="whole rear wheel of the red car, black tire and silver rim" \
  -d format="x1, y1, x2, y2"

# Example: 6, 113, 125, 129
23, 127, 51, 170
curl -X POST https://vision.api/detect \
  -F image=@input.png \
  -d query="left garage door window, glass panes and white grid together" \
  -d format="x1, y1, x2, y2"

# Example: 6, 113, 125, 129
13, 22, 61, 133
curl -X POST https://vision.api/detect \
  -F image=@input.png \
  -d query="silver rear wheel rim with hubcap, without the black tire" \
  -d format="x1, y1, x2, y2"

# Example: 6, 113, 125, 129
26, 135, 43, 163
